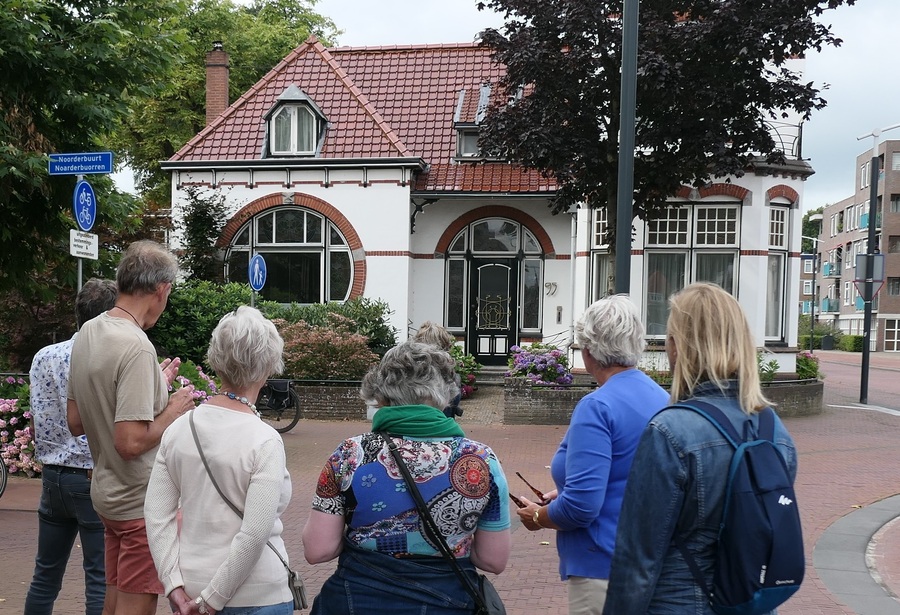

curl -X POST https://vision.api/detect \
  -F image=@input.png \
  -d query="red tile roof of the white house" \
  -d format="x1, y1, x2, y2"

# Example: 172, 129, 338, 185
171, 37, 555, 192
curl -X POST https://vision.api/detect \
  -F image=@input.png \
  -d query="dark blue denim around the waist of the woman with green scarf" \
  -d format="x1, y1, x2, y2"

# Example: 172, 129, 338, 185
310, 540, 477, 615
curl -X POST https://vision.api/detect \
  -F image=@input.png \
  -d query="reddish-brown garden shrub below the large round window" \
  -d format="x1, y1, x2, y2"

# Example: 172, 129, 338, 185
273, 313, 379, 380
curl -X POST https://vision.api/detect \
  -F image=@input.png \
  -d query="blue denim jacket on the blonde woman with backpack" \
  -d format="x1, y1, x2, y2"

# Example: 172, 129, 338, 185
603, 381, 797, 615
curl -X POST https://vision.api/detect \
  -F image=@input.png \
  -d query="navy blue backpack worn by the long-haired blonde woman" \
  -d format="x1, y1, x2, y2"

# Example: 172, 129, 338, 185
670, 400, 806, 615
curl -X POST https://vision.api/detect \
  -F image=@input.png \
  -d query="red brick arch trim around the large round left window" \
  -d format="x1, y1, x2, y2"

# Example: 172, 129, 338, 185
217, 192, 366, 299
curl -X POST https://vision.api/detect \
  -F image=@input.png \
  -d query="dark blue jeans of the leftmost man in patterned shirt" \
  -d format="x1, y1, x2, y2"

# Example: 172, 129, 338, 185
25, 466, 106, 615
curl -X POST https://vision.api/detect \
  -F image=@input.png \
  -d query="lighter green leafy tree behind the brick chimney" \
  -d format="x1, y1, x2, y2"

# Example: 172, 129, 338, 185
113, 0, 339, 208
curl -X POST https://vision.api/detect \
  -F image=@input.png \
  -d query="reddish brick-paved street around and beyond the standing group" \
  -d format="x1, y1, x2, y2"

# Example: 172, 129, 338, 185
0, 352, 900, 615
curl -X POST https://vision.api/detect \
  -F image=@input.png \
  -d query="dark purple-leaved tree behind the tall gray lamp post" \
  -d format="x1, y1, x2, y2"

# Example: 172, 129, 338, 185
478, 0, 855, 250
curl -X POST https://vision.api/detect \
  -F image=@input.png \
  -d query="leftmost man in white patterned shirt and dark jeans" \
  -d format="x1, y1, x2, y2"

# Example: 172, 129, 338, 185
25, 278, 116, 615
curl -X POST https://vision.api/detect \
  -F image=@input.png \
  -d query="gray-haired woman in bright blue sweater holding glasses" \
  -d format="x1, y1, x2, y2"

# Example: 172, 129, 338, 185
517, 295, 668, 615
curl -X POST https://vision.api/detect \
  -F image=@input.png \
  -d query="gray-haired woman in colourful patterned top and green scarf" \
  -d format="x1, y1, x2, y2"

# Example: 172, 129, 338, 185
303, 341, 510, 615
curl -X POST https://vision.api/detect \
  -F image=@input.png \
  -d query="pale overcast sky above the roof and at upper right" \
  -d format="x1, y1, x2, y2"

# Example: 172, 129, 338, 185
314, 0, 900, 209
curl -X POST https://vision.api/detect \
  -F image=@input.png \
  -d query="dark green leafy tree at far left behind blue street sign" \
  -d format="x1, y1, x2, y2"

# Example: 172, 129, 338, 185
0, 0, 184, 296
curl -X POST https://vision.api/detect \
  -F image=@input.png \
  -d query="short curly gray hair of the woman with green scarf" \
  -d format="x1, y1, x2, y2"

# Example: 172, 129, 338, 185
360, 341, 459, 409
